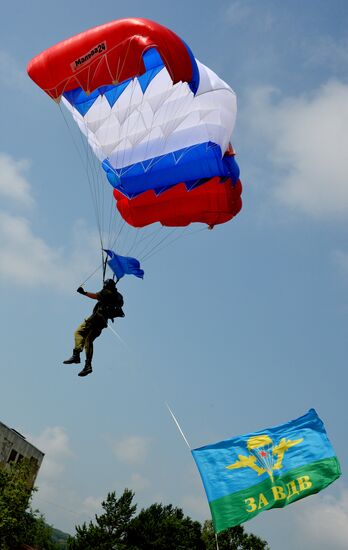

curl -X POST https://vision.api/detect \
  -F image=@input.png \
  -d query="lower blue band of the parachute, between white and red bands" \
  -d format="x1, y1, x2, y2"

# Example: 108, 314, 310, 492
102, 146, 239, 198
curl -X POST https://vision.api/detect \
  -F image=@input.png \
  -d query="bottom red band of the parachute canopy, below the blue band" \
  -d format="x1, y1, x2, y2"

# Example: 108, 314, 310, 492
113, 177, 242, 227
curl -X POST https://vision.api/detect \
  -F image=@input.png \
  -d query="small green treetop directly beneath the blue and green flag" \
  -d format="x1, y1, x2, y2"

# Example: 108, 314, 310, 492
202, 520, 269, 550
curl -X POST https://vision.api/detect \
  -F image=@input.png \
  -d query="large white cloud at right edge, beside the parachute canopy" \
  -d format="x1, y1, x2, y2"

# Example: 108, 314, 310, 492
247, 81, 348, 219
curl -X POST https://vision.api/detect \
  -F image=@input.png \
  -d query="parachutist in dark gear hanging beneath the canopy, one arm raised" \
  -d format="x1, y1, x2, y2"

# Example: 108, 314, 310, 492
63, 279, 124, 376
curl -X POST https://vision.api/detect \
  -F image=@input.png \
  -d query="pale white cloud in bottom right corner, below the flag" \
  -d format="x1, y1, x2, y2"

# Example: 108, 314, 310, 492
298, 489, 348, 550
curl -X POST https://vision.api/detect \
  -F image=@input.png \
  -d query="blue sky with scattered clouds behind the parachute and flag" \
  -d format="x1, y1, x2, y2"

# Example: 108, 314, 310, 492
0, 0, 348, 550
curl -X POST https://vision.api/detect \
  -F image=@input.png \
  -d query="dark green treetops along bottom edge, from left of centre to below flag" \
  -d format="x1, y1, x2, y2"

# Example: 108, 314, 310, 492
67, 489, 269, 550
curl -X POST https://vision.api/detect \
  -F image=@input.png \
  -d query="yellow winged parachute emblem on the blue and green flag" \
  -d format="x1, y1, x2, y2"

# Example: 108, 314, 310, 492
226, 435, 303, 482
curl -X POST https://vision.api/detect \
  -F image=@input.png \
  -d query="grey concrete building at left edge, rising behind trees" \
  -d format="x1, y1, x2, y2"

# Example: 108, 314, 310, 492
0, 422, 44, 485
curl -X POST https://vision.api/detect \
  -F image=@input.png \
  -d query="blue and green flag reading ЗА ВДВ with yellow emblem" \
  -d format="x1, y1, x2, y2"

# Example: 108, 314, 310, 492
192, 409, 341, 533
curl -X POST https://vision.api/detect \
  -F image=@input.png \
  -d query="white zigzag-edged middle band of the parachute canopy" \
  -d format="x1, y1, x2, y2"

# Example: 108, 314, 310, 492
62, 60, 237, 170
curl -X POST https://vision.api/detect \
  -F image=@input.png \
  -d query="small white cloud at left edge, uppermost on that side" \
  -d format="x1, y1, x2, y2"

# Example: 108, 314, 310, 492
0, 153, 34, 206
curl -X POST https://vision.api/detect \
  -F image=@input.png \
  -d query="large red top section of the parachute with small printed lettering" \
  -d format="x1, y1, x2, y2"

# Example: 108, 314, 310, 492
27, 18, 192, 99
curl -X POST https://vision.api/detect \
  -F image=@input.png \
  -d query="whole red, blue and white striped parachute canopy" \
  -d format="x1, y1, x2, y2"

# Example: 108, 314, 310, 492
28, 18, 241, 227
